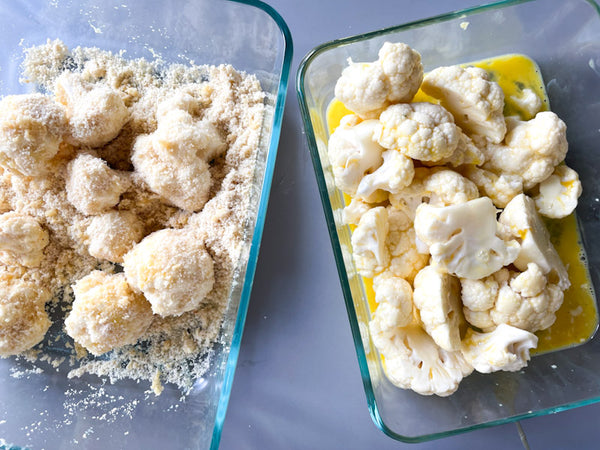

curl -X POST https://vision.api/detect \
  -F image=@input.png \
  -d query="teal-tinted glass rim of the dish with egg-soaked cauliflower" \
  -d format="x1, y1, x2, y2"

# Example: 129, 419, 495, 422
296, 0, 600, 443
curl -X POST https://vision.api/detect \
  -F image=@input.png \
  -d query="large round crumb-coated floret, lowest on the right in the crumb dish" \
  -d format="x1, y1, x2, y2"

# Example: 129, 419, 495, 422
123, 228, 215, 317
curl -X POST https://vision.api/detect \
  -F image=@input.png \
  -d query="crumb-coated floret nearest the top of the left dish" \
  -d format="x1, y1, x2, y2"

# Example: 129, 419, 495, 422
54, 71, 129, 147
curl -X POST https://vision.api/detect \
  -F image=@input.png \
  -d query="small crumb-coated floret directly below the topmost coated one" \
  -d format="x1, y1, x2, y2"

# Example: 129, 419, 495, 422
65, 153, 129, 215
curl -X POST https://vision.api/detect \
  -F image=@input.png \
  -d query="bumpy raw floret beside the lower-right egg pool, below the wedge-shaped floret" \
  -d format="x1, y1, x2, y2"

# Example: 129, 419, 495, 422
461, 263, 563, 333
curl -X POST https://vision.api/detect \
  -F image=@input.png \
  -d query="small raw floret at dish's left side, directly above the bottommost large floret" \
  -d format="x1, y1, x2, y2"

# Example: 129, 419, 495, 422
373, 271, 413, 329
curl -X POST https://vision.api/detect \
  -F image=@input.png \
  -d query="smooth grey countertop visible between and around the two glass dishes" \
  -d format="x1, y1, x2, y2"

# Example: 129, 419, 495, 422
221, 0, 600, 450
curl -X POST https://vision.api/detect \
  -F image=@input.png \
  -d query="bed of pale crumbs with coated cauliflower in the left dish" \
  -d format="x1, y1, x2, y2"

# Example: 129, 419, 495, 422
0, 40, 265, 393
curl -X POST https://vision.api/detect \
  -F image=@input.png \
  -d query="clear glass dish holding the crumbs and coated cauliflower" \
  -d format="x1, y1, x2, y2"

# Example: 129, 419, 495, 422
0, 0, 292, 449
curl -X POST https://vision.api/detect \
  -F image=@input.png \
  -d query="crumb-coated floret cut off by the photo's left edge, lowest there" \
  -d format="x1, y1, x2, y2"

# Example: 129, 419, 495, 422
0, 273, 51, 358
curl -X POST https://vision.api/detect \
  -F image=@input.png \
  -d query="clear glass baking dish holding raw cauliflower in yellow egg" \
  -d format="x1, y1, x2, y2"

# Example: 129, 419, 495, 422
296, 0, 600, 442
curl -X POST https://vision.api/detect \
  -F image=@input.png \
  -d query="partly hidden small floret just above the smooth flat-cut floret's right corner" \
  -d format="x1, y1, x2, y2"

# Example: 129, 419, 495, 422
461, 166, 523, 208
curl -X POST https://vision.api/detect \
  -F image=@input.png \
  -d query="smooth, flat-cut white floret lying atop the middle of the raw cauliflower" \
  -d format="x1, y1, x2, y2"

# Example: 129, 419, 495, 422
415, 197, 519, 279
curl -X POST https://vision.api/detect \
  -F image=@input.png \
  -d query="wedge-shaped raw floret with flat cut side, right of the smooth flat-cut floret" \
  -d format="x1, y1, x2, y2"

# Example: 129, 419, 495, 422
499, 194, 571, 290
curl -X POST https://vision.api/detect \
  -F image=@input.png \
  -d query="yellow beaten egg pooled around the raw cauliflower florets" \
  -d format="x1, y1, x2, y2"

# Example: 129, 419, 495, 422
327, 54, 598, 354
